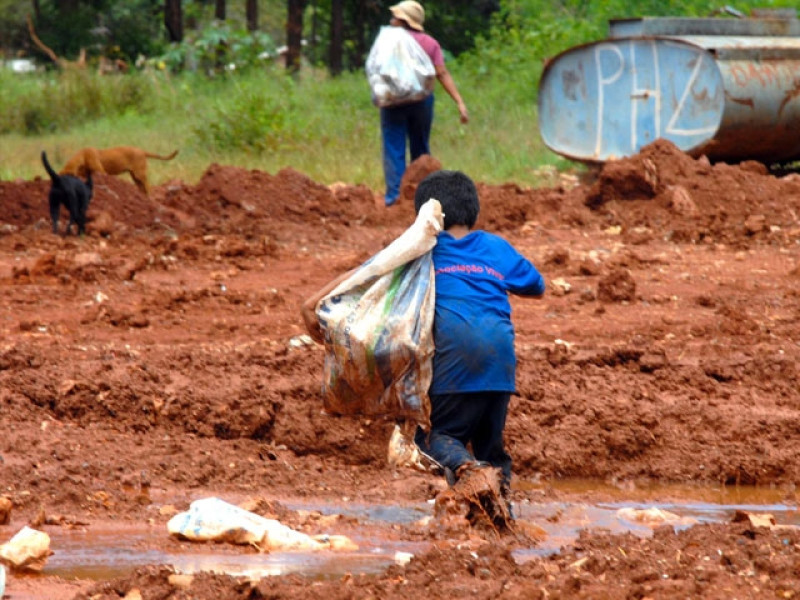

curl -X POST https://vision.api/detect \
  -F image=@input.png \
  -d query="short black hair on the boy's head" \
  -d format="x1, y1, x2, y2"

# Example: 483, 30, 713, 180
414, 170, 481, 229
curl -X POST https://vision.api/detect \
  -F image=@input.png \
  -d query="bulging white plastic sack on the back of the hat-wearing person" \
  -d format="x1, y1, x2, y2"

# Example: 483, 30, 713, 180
365, 25, 436, 107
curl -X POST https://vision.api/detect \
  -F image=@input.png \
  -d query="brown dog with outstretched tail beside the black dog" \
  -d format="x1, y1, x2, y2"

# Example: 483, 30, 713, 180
59, 146, 178, 196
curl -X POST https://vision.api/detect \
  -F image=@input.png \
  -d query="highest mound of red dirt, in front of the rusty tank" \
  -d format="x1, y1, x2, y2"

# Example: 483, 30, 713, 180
585, 140, 800, 246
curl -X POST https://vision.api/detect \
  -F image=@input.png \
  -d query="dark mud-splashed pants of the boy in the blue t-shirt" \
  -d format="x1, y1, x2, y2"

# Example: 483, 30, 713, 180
414, 392, 511, 488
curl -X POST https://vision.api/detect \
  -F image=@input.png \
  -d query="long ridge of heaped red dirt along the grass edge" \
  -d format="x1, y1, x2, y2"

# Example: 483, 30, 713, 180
0, 140, 800, 247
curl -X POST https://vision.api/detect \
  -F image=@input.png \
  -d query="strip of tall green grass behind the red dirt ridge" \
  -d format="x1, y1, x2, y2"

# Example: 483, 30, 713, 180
0, 62, 563, 190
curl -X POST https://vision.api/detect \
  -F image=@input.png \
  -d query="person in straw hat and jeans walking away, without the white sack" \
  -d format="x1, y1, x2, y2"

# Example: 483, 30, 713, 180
380, 0, 469, 206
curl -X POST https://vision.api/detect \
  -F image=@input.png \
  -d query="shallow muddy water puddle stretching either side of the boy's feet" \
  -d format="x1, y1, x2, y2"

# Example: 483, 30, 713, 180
44, 481, 800, 580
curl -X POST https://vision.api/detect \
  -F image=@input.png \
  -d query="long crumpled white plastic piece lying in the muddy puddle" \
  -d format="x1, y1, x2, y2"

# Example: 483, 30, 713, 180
167, 498, 357, 552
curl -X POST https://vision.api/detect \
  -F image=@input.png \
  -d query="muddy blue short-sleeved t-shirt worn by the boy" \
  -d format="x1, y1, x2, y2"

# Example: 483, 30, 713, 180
430, 231, 545, 394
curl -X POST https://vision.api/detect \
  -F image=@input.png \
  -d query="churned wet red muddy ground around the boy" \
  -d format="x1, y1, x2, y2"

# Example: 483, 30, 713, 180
0, 142, 800, 600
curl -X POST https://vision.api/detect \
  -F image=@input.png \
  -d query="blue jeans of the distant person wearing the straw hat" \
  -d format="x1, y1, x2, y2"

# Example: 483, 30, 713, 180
381, 94, 433, 206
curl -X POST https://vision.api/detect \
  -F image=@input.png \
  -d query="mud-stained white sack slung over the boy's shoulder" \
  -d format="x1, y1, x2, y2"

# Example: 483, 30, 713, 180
316, 199, 442, 427
